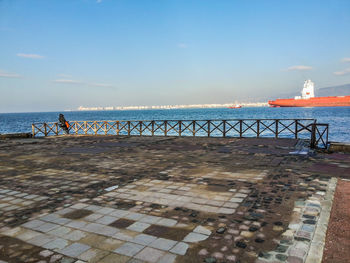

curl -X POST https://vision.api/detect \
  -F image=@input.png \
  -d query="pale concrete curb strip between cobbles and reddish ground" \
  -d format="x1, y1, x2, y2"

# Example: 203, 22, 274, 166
305, 177, 337, 263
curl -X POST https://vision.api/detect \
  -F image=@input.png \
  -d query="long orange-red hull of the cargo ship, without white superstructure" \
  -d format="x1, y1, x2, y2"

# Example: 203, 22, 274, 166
269, 96, 350, 107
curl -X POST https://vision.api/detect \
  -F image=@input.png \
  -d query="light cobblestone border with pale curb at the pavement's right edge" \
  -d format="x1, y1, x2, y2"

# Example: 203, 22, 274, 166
256, 177, 337, 263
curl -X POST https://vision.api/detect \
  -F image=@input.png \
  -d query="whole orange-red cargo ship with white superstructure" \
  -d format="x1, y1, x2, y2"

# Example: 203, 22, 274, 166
269, 80, 350, 107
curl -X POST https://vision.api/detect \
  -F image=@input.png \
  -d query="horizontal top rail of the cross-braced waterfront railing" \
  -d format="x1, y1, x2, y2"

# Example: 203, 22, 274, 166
33, 118, 316, 125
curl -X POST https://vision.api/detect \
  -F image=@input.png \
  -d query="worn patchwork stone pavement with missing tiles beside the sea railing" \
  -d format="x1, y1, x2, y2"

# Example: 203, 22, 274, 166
0, 136, 350, 263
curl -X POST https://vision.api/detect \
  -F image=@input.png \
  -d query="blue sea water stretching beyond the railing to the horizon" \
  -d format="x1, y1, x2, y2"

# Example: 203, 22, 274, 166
0, 107, 350, 142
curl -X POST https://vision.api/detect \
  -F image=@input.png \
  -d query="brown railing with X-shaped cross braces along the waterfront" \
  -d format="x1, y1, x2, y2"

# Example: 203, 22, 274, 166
32, 119, 328, 148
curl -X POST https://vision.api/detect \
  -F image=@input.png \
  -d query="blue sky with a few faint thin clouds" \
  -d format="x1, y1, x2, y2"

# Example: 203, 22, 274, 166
0, 0, 350, 112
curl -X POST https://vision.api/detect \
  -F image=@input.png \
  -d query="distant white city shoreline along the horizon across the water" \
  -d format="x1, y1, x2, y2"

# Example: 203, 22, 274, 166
77, 102, 268, 111
